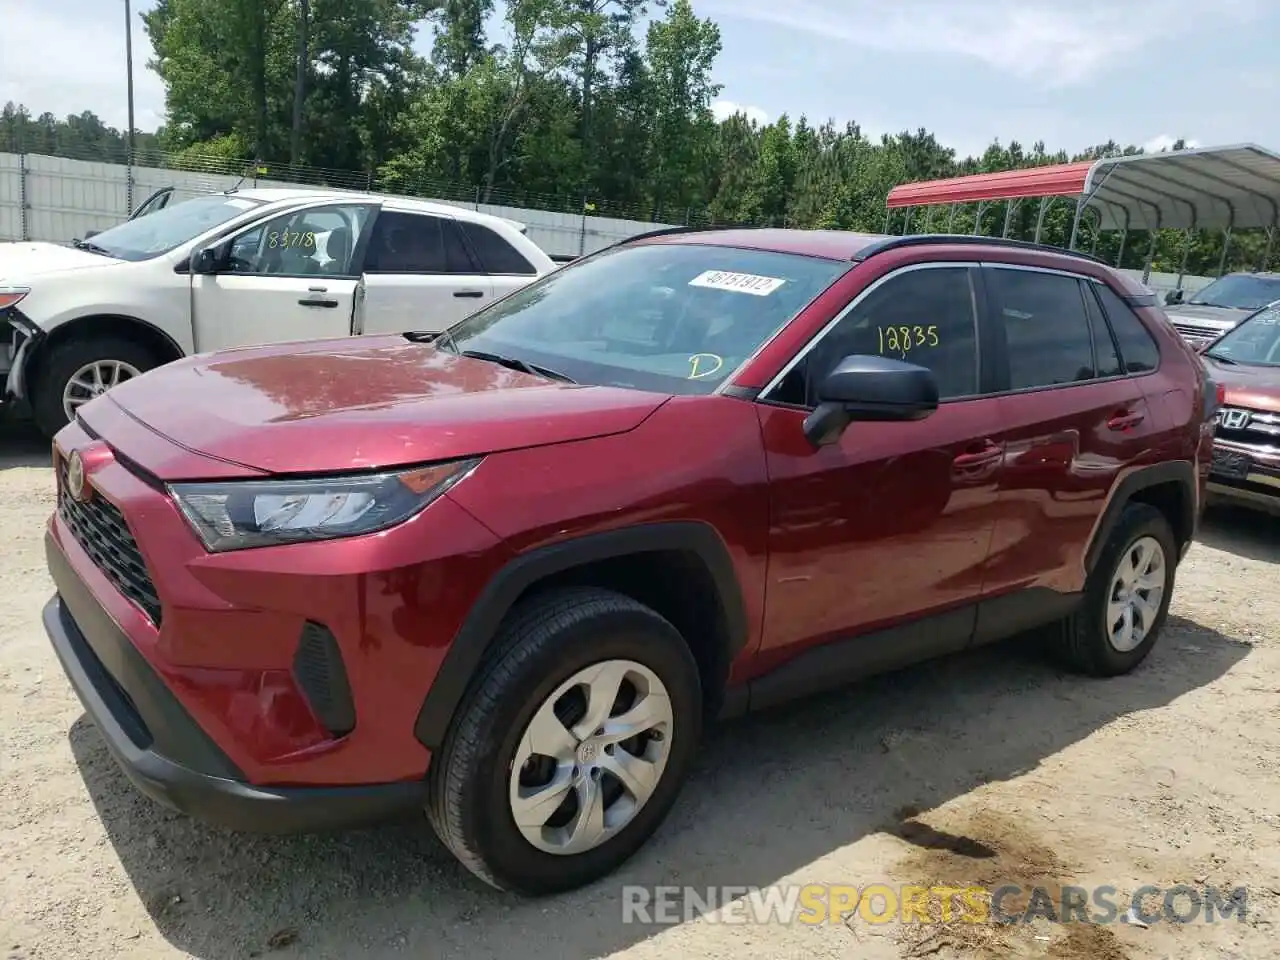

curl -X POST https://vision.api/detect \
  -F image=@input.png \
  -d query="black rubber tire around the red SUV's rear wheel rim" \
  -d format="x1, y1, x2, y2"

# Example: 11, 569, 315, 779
1056, 503, 1178, 677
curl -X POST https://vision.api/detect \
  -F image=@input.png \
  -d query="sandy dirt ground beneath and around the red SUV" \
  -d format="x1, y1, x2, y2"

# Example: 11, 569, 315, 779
0, 429, 1280, 960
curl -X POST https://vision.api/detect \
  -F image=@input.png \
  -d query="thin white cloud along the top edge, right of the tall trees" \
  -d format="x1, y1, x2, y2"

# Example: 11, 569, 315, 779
700, 0, 1268, 89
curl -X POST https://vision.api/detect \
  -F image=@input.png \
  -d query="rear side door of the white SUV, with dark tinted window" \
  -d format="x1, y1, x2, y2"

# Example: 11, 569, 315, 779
358, 209, 494, 334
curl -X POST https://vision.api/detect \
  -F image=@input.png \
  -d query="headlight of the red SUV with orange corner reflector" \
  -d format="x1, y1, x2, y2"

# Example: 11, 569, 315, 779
169, 458, 480, 553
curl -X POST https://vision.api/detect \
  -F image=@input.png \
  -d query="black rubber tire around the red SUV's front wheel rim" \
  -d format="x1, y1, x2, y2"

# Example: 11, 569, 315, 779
426, 588, 703, 896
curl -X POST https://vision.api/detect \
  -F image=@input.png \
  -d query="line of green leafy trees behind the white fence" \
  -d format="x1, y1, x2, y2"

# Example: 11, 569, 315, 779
12, 0, 1280, 274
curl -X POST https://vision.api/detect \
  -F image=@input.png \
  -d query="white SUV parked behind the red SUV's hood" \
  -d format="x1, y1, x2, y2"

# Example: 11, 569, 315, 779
0, 189, 557, 435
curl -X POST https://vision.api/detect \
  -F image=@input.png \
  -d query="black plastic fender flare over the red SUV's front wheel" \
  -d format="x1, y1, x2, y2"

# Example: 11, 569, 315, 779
413, 521, 748, 751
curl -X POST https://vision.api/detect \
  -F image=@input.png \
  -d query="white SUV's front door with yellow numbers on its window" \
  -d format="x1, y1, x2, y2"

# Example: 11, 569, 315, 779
191, 202, 374, 352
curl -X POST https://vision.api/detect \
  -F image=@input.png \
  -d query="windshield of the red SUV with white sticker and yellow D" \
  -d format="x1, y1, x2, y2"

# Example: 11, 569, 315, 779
438, 243, 851, 394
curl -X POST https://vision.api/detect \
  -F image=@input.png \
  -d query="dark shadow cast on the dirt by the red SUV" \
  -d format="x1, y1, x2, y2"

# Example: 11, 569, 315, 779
69, 617, 1251, 960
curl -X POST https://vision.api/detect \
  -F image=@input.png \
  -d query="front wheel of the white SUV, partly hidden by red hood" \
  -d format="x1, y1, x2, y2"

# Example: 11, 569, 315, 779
31, 337, 159, 436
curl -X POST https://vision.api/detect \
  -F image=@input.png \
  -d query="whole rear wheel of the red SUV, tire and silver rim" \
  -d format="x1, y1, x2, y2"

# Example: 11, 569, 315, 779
1057, 503, 1178, 677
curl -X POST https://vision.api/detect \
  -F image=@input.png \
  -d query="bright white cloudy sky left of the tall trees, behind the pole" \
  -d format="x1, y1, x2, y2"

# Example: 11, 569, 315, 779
0, 0, 164, 131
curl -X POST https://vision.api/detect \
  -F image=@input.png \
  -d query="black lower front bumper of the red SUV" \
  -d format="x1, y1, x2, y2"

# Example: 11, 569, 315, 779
44, 536, 426, 833
